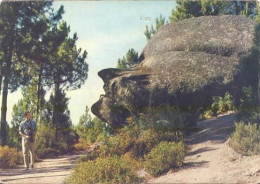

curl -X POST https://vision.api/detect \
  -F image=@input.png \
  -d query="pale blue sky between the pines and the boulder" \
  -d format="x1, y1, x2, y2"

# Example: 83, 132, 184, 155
1, 1, 175, 125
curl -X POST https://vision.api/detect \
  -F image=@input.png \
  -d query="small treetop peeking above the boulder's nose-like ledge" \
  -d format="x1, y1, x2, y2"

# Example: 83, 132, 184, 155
117, 48, 139, 69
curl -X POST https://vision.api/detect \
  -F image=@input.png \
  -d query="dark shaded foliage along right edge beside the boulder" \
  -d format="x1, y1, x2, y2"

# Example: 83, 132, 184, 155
236, 24, 260, 123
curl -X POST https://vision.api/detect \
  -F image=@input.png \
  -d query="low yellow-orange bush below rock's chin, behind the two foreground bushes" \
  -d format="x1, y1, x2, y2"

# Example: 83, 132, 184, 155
98, 125, 183, 158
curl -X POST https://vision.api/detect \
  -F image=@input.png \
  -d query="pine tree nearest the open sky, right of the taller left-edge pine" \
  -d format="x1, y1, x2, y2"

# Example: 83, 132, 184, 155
42, 21, 88, 139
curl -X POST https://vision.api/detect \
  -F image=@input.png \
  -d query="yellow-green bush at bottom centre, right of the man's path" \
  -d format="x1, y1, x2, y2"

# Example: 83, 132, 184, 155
67, 156, 140, 184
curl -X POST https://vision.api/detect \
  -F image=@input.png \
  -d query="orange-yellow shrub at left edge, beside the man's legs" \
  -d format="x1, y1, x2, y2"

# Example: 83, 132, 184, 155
0, 146, 23, 168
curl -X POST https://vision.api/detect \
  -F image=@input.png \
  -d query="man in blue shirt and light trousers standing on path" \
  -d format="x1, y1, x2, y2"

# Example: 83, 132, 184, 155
19, 111, 37, 170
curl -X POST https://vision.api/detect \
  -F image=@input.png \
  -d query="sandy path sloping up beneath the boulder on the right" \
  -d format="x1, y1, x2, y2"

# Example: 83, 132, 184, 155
149, 114, 260, 184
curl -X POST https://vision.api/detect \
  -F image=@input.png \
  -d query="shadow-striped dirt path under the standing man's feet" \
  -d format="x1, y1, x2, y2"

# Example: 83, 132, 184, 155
0, 153, 83, 184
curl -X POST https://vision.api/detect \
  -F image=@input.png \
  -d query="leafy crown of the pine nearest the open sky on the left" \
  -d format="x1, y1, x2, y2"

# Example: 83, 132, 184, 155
47, 21, 88, 93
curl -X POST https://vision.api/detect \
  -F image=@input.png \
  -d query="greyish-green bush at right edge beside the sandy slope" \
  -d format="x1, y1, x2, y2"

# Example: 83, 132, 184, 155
229, 122, 260, 155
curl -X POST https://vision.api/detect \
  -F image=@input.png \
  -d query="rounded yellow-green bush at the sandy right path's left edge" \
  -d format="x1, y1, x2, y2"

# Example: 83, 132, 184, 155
144, 141, 186, 176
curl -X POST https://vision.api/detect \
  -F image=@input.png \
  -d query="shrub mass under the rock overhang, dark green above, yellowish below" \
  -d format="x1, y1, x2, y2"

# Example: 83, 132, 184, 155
96, 108, 184, 158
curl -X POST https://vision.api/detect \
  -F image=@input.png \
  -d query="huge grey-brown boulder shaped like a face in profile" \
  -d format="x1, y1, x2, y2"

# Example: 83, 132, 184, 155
92, 16, 255, 128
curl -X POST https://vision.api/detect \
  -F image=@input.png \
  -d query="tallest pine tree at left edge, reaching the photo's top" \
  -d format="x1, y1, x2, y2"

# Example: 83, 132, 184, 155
0, 1, 52, 145
